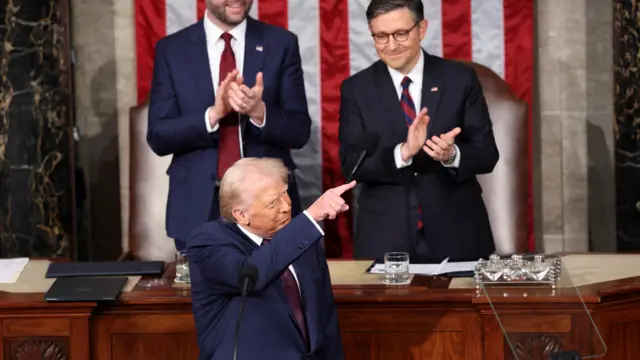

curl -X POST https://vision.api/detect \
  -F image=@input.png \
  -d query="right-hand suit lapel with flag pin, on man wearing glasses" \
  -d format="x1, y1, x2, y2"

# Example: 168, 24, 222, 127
420, 51, 444, 137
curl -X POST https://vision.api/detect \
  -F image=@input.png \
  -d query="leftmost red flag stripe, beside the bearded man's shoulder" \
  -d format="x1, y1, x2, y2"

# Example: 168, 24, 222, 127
134, 0, 167, 104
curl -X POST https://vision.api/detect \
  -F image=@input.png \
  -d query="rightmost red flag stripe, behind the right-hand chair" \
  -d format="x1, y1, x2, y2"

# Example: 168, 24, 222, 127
503, 0, 535, 251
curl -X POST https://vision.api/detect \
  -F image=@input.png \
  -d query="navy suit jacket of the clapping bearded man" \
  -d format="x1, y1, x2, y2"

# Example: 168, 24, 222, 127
147, 18, 311, 240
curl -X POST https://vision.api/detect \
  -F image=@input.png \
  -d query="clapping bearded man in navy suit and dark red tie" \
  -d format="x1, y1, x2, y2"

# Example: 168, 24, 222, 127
147, 0, 311, 250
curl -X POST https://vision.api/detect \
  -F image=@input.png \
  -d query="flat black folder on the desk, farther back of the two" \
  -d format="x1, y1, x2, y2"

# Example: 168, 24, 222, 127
45, 261, 164, 278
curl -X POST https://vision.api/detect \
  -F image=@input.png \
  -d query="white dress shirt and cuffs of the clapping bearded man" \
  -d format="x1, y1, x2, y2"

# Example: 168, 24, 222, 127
203, 10, 267, 149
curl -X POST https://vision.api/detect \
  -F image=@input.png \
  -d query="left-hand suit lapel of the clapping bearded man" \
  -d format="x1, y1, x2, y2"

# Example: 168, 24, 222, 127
184, 20, 215, 107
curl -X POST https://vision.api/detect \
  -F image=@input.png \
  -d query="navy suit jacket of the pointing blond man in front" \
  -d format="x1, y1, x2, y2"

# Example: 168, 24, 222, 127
187, 213, 344, 360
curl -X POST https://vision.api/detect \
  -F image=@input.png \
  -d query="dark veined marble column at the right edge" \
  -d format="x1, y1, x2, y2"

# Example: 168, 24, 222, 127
614, 0, 640, 252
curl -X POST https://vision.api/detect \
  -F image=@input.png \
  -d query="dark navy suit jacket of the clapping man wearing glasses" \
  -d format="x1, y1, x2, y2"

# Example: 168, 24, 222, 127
339, 52, 499, 261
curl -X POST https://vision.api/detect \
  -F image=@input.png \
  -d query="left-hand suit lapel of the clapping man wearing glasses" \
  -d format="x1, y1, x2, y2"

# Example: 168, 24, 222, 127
374, 61, 407, 139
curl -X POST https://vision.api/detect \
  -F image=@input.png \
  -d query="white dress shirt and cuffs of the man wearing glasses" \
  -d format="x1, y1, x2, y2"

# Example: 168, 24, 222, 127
387, 51, 460, 169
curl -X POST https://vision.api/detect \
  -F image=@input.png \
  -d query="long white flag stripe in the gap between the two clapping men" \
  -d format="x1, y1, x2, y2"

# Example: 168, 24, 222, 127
289, 0, 322, 208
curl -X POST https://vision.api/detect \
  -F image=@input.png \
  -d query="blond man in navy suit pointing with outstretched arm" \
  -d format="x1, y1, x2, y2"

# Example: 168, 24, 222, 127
187, 158, 344, 360
